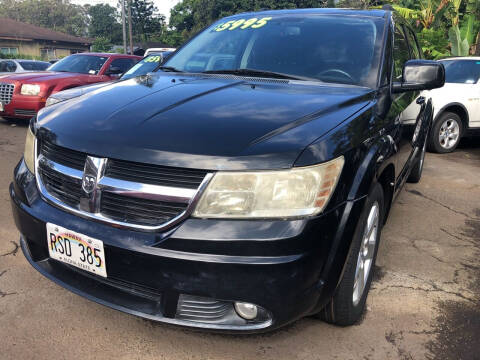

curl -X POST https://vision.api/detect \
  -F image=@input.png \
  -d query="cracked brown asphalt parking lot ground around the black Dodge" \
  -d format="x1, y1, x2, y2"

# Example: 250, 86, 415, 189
0, 119, 480, 360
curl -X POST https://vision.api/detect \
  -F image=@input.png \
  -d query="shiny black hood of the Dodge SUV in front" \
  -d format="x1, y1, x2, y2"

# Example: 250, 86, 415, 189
37, 73, 373, 170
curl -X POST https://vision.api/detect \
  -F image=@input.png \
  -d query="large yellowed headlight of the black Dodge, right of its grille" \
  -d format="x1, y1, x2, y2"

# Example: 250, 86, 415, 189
193, 156, 344, 219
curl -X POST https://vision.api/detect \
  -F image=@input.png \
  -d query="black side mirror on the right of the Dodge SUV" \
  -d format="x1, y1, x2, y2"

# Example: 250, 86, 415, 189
392, 60, 445, 93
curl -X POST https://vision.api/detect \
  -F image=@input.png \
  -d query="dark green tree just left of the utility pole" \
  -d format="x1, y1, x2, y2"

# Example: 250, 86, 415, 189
86, 4, 122, 43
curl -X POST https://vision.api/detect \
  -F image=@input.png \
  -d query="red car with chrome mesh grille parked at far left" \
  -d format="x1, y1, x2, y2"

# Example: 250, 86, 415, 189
0, 53, 142, 119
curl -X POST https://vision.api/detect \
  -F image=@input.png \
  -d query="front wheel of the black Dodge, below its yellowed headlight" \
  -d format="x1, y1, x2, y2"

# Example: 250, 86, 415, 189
319, 183, 384, 326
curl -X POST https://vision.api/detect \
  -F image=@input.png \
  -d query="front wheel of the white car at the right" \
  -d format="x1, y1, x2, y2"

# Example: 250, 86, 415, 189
429, 112, 463, 154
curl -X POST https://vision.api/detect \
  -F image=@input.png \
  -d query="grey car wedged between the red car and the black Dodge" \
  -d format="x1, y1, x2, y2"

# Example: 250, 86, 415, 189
45, 54, 168, 106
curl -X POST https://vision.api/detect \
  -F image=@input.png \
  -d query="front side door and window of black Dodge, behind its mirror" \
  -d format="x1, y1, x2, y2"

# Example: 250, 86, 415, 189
392, 23, 425, 182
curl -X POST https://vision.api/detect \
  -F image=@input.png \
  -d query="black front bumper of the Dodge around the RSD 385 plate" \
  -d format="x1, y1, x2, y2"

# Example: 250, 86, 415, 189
10, 161, 363, 332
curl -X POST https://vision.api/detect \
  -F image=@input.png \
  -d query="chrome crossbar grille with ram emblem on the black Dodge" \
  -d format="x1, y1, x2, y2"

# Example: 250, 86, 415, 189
37, 141, 212, 231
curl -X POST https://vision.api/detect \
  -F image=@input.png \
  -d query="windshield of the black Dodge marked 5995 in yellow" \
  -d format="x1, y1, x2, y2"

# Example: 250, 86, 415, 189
165, 14, 384, 87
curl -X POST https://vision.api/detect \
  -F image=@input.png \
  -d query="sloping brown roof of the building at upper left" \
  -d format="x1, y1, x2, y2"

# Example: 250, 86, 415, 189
0, 17, 92, 45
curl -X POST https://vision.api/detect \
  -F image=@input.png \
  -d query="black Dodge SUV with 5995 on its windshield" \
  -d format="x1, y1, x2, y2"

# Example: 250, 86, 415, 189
10, 9, 445, 332
